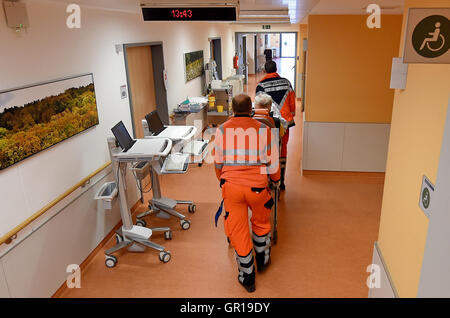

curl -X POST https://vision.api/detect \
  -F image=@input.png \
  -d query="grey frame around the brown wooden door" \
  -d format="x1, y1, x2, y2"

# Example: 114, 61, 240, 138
122, 41, 169, 136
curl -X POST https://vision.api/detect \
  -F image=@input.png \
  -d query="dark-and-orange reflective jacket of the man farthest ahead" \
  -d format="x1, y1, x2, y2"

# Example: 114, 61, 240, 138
256, 73, 295, 127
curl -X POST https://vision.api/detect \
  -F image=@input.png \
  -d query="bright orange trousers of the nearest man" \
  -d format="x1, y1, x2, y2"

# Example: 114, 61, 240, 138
222, 182, 274, 256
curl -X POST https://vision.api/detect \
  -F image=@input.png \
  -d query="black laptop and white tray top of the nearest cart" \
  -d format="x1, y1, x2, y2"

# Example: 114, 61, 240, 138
111, 121, 172, 158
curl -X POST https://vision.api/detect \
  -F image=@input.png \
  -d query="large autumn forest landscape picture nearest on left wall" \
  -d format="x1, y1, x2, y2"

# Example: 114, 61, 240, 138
0, 74, 99, 170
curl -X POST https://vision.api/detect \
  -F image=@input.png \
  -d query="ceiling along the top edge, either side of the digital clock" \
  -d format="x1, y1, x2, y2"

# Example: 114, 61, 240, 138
43, 0, 404, 23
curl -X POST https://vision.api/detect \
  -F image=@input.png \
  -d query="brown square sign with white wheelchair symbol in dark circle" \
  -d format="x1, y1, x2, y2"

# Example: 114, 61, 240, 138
403, 8, 450, 64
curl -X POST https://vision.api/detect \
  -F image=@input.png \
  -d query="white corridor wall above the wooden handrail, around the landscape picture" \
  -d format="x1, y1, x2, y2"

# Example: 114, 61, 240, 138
0, 0, 233, 236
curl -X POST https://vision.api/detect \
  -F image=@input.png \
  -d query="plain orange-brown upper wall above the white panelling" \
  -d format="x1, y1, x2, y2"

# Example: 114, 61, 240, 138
306, 15, 402, 123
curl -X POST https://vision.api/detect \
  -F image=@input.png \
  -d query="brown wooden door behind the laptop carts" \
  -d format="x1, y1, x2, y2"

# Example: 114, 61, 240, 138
127, 46, 156, 138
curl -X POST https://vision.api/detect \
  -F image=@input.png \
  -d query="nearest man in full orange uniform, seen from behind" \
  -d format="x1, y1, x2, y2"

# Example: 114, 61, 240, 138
214, 94, 280, 292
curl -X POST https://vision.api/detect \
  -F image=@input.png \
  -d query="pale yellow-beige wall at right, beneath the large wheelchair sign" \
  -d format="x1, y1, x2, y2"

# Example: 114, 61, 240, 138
378, 0, 450, 297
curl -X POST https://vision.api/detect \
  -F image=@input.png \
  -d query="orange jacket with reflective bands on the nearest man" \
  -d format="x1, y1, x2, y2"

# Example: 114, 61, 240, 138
213, 115, 280, 188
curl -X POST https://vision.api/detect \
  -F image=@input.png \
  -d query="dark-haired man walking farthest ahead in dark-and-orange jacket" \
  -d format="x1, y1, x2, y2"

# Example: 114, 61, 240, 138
256, 61, 296, 190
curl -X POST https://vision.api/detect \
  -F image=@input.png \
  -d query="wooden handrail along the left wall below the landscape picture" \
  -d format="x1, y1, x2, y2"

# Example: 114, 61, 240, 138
0, 161, 111, 245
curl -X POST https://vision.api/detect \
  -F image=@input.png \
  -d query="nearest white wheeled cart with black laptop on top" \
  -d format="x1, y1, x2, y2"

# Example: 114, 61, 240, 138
105, 122, 172, 268
